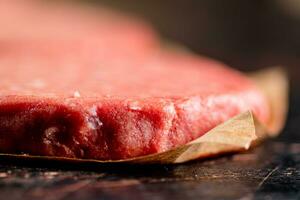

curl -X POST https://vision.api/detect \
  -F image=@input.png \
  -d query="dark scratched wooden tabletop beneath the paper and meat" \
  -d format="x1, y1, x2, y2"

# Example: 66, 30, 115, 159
0, 95, 300, 200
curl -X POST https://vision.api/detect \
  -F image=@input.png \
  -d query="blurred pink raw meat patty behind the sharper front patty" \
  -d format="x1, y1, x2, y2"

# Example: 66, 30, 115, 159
0, 0, 158, 58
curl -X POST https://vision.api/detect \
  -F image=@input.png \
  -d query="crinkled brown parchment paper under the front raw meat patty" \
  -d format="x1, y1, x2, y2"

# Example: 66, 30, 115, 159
0, 68, 288, 164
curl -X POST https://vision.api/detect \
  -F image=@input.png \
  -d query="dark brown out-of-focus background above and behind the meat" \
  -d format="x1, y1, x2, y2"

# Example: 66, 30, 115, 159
84, 0, 300, 141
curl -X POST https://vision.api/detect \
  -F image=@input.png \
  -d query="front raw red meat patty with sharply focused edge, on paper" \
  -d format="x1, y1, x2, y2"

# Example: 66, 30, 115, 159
0, 0, 269, 160
